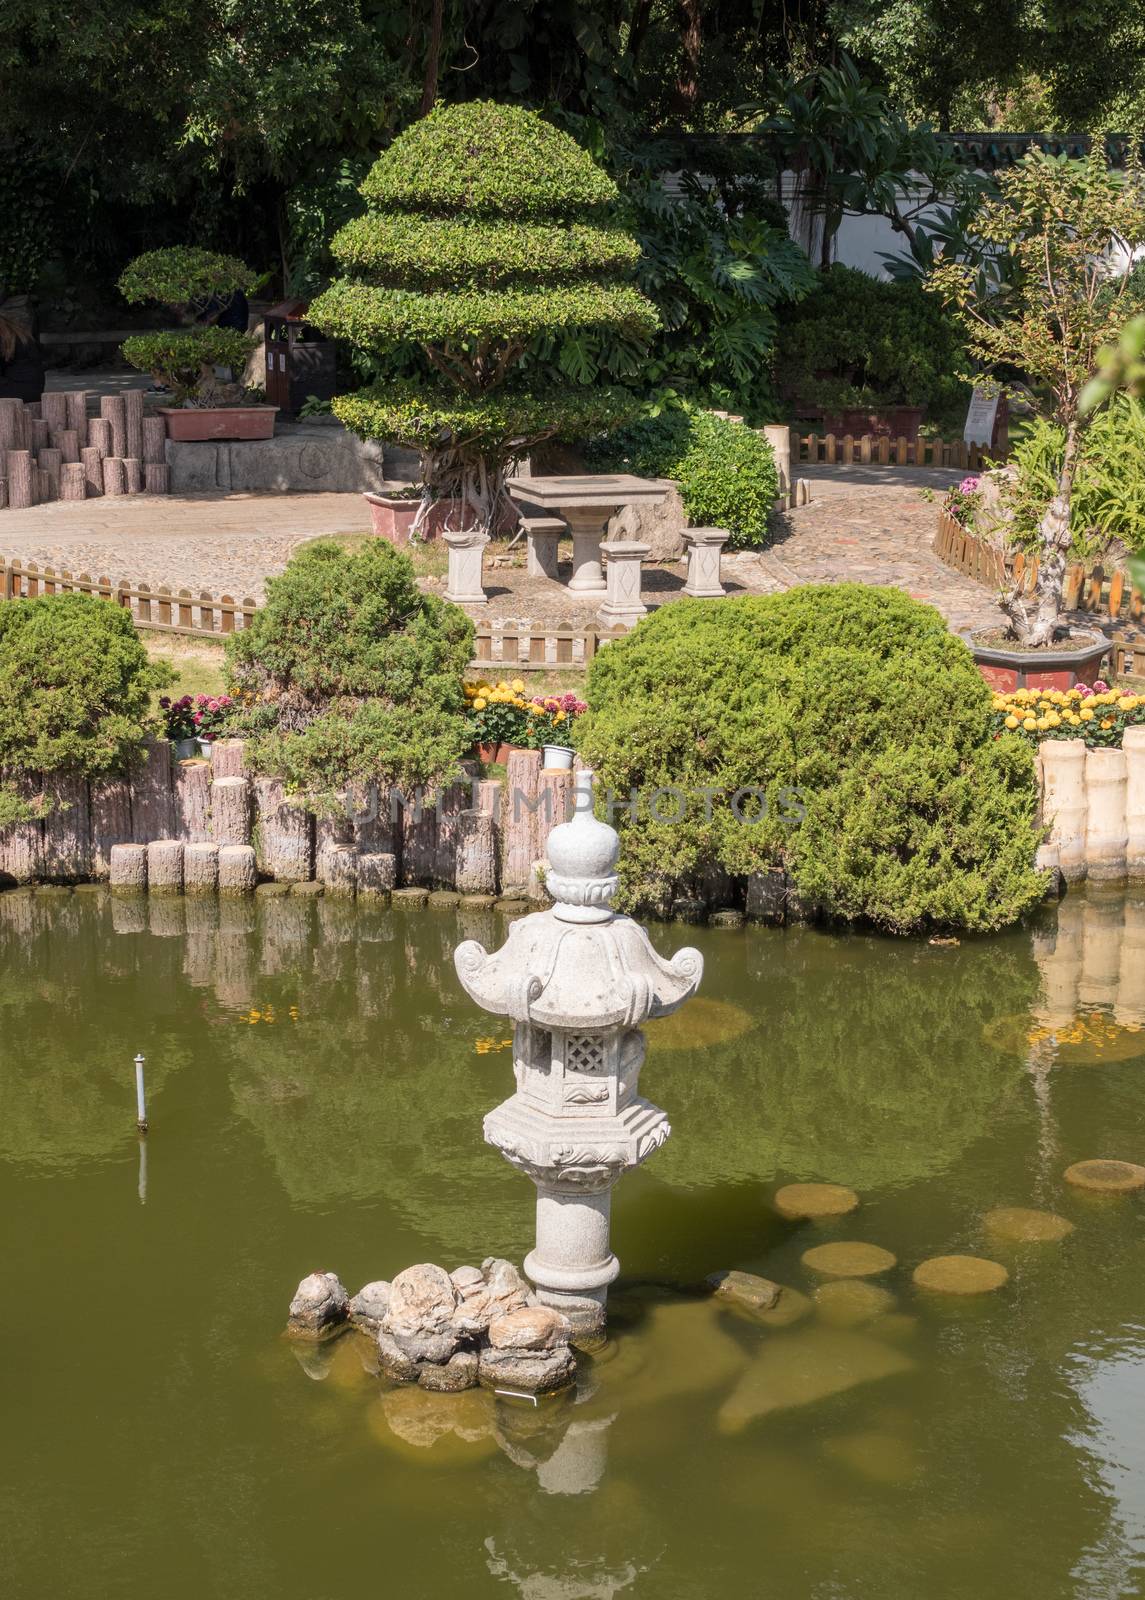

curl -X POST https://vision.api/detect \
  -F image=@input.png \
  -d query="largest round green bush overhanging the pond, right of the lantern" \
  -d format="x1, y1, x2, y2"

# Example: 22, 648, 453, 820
577, 584, 1044, 933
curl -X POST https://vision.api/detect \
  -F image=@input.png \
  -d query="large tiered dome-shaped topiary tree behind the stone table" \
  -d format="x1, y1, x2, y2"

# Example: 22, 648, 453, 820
310, 102, 657, 531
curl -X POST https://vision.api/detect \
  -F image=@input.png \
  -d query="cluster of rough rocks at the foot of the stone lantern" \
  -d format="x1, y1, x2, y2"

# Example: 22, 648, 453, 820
288, 1256, 576, 1395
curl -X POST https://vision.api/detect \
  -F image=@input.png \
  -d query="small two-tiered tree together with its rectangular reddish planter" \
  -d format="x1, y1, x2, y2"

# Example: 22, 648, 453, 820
118, 248, 278, 442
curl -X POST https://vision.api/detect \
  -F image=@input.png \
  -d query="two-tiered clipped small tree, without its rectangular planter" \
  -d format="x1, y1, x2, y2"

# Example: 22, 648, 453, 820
118, 246, 256, 405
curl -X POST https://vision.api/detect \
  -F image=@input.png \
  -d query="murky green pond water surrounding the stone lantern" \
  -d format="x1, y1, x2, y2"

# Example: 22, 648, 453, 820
0, 893, 1145, 1600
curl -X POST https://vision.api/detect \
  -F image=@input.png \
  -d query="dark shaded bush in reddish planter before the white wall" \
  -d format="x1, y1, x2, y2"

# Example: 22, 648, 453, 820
776, 266, 969, 413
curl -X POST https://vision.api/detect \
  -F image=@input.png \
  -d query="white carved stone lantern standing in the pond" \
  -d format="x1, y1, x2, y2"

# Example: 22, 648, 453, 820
454, 771, 704, 1333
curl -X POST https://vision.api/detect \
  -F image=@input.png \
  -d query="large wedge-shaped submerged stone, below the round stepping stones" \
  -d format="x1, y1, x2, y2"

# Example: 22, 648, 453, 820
716, 1328, 915, 1434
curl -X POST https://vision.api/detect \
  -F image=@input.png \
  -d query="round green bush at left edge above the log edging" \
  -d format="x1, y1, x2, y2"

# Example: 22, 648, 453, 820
0, 595, 170, 822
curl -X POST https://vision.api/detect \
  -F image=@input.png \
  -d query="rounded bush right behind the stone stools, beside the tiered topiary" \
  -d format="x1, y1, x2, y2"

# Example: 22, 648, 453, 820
588, 410, 779, 549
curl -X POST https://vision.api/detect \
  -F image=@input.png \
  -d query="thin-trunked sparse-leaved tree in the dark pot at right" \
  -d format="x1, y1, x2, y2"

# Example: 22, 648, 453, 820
929, 139, 1145, 646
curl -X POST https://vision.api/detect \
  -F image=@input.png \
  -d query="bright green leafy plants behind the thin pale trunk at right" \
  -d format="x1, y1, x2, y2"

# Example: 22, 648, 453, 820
1004, 398, 1145, 562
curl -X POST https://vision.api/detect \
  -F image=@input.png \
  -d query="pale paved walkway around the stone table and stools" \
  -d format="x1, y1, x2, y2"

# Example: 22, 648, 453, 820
0, 467, 999, 627
